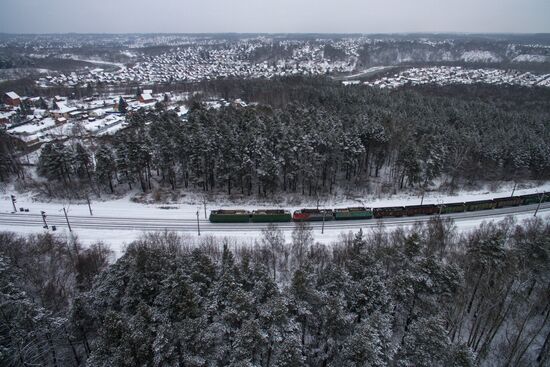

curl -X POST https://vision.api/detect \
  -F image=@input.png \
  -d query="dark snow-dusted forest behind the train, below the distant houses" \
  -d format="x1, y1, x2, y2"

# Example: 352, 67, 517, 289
33, 80, 550, 196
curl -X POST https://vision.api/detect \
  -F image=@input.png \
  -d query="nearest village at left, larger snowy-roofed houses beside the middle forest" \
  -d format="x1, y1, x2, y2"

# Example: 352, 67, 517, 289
0, 89, 196, 152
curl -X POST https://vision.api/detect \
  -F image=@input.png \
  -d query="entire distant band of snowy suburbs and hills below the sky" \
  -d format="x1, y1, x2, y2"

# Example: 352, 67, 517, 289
0, 34, 550, 89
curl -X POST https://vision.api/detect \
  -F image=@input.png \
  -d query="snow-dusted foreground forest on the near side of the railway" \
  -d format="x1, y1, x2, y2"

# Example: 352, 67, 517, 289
0, 218, 550, 367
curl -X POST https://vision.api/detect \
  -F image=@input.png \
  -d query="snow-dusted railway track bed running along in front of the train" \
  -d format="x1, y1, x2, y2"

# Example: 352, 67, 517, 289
0, 203, 550, 234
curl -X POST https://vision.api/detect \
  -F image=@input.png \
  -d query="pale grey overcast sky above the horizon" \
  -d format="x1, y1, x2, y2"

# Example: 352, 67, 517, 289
0, 0, 550, 33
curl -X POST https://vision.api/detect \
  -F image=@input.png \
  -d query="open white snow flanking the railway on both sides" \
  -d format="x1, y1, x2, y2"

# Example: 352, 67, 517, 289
0, 183, 550, 255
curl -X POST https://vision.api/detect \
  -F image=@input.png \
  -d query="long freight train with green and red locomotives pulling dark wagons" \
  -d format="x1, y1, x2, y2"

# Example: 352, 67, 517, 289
210, 192, 550, 223
